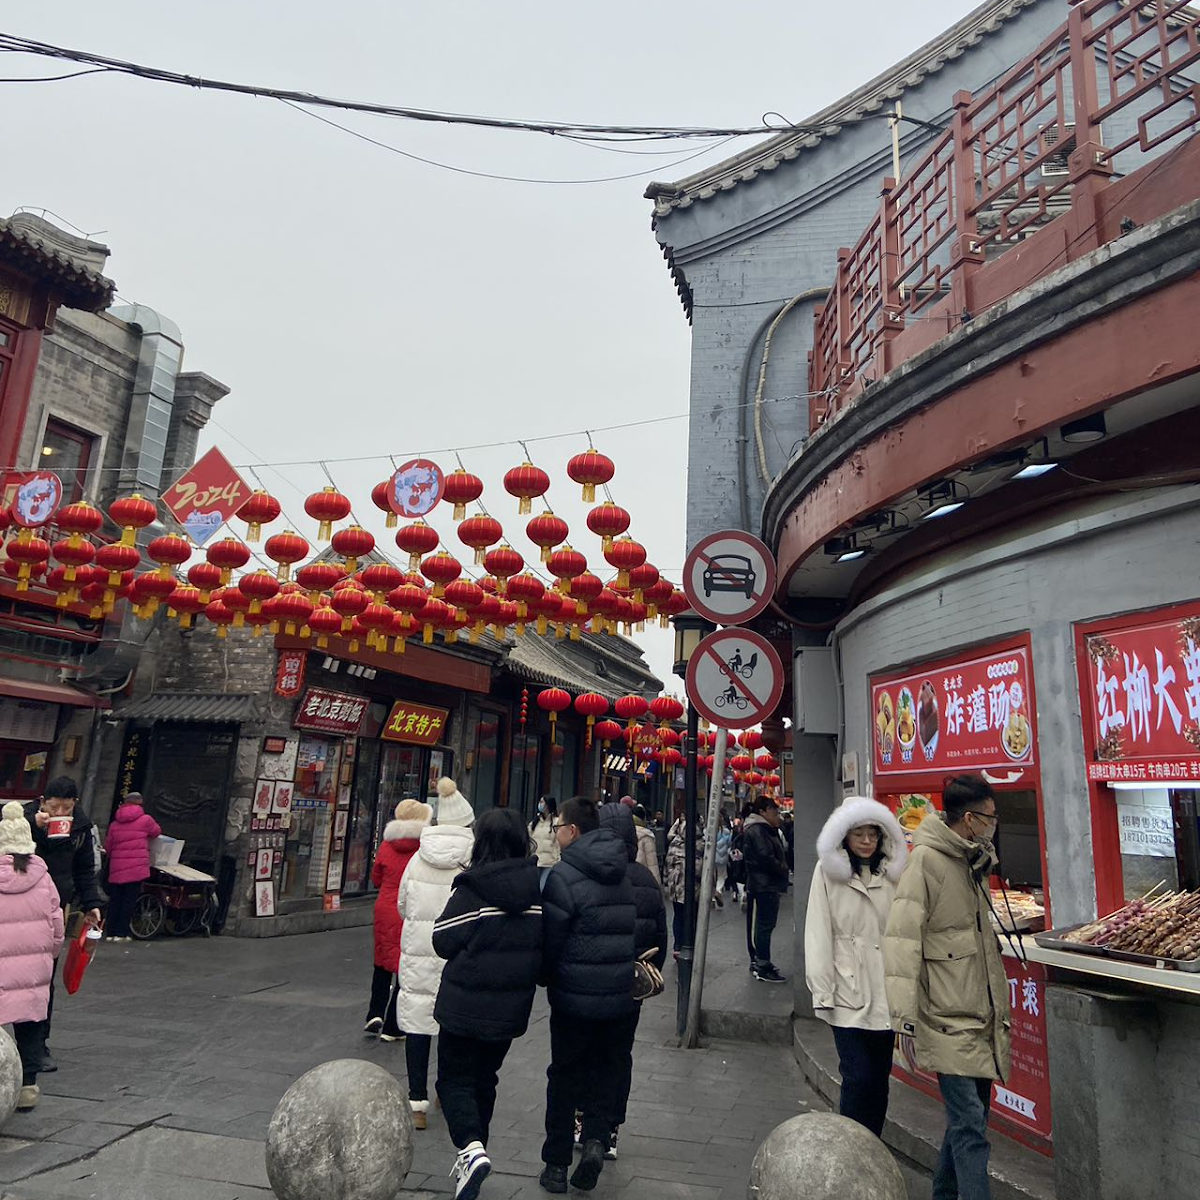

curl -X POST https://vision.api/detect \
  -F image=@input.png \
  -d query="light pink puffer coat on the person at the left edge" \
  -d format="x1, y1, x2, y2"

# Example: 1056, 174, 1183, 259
0, 854, 62, 1025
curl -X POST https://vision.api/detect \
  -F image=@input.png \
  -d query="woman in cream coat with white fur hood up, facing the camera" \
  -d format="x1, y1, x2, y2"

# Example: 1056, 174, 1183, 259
804, 796, 908, 1136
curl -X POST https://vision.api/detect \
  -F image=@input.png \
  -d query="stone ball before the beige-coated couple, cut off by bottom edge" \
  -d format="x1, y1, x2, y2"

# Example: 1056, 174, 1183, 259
746, 1112, 908, 1200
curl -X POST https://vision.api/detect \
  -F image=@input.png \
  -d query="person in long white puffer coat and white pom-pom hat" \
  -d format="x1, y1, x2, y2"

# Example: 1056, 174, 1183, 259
396, 779, 475, 1129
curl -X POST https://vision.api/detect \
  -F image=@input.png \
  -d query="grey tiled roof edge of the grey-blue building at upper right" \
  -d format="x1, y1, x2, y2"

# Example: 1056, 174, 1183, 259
644, 0, 1040, 218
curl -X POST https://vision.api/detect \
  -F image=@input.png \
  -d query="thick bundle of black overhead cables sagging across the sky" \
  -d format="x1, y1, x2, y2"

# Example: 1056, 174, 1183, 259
0, 34, 826, 140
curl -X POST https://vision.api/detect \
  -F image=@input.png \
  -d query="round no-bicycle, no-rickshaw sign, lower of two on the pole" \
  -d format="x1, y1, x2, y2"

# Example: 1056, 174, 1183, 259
688, 629, 784, 730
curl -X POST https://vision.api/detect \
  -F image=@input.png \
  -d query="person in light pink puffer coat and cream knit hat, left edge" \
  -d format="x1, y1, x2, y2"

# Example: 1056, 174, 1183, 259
0, 800, 62, 1112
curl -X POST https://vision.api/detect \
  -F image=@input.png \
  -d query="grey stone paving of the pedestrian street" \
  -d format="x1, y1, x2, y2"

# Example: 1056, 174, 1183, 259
0, 914, 820, 1200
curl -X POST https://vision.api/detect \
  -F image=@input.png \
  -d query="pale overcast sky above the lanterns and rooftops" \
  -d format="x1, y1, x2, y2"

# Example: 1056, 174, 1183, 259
0, 0, 973, 678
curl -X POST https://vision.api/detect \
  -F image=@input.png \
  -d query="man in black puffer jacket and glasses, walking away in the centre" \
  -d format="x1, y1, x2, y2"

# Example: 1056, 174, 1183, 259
539, 797, 637, 1193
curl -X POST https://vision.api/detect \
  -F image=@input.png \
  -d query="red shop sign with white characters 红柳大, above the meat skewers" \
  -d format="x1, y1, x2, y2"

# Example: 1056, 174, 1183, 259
1084, 605, 1200, 781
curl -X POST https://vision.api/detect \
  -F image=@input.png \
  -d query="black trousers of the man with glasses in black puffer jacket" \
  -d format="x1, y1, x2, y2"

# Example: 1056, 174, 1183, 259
541, 1009, 631, 1166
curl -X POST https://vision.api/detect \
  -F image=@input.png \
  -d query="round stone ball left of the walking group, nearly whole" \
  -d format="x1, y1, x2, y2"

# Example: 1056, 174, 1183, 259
266, 1058, 413, 1200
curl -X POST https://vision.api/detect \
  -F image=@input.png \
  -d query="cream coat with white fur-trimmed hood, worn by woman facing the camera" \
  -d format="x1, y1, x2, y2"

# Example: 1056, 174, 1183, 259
804, 796, 908, 1030
